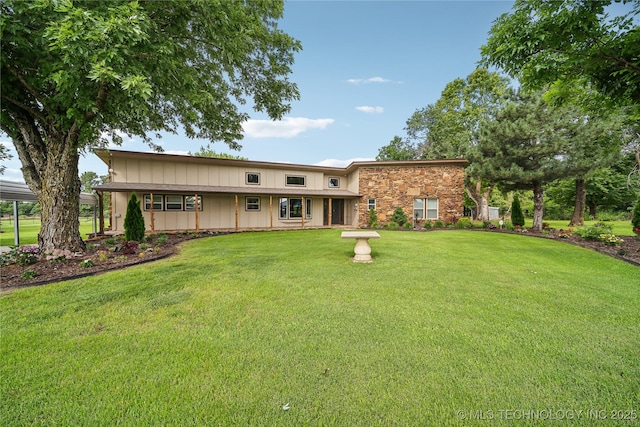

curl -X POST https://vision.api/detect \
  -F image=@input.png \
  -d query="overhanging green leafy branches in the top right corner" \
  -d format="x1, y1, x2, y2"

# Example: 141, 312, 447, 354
482, 0, 640, 113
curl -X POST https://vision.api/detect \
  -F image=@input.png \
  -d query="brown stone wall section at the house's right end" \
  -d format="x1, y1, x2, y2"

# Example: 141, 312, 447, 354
358, 165, 464, 227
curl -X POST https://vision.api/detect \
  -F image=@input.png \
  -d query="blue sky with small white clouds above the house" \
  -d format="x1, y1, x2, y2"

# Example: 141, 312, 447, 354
0, 0, 513, 181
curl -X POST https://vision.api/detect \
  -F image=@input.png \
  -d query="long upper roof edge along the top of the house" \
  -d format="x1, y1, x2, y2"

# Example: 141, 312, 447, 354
94, 149, 469, 175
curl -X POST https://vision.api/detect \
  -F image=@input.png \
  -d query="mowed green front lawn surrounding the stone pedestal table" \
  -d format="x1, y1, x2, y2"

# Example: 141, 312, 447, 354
0, 230, 640, 426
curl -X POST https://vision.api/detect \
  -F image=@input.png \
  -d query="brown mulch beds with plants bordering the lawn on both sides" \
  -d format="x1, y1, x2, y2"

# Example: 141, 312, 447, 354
0, 229, 640, 292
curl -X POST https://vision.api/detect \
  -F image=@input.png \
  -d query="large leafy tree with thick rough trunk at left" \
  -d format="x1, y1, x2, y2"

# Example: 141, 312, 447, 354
0, 0, 300, 250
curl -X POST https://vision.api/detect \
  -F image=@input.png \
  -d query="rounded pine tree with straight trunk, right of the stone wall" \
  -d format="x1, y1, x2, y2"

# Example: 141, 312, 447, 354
469, 91, 576, 231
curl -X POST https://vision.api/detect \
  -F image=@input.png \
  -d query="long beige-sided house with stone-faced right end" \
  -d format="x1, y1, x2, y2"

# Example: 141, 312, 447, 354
95, 150, 468, 233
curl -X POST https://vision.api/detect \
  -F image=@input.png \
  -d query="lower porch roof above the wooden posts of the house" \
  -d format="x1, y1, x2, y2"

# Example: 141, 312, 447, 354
94, 182, 360, 198
